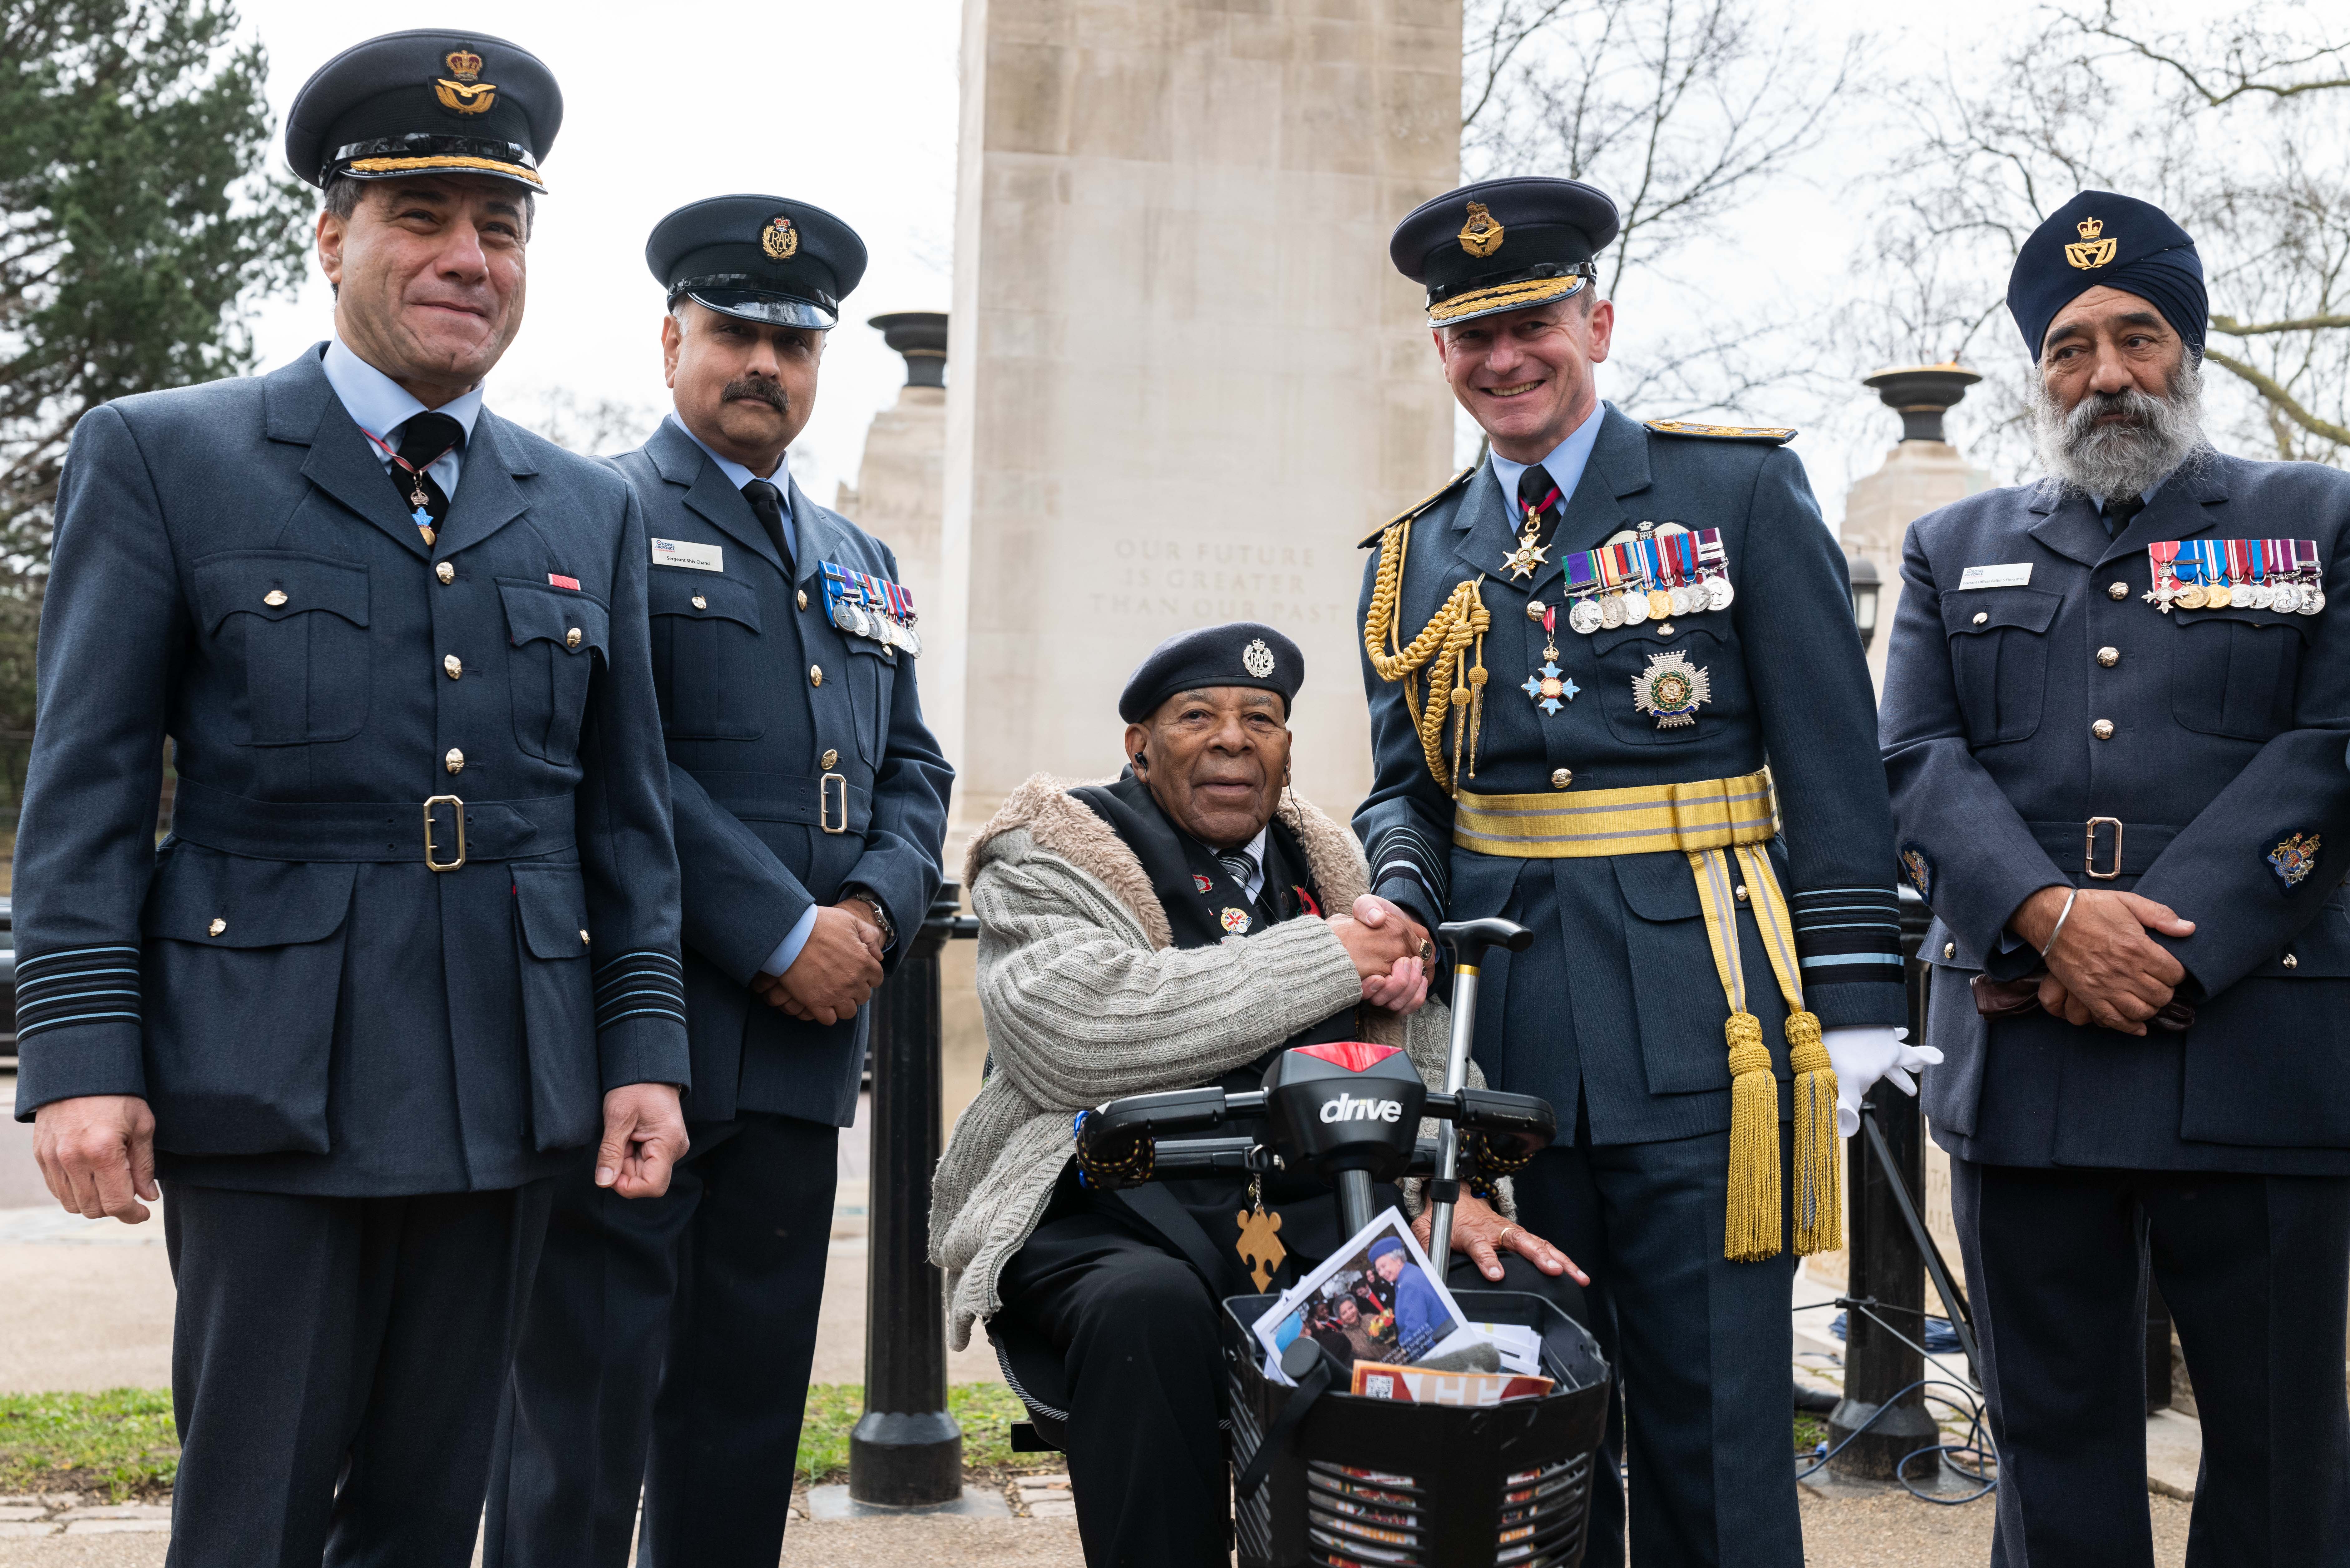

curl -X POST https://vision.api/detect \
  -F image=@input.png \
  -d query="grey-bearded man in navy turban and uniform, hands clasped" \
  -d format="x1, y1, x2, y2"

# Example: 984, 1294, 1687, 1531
1882, 190, 2350, 1566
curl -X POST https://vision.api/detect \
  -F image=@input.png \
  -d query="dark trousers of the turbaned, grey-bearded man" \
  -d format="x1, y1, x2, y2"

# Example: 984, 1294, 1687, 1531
1951, 1159, 2350, 1568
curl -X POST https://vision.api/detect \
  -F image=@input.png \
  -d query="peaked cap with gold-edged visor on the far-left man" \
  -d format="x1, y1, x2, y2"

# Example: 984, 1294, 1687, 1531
287, 28, 564, 190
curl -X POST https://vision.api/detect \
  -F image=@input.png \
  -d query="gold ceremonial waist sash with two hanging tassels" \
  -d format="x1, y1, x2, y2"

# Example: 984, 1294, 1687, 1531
1452, 771, 1845, 1262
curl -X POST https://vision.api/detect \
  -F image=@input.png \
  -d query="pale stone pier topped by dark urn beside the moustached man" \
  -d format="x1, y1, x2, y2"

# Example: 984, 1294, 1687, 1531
832, 310, 947, 620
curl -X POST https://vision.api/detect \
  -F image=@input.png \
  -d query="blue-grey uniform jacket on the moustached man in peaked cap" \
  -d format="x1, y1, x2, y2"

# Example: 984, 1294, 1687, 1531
613, 421, 954, 1126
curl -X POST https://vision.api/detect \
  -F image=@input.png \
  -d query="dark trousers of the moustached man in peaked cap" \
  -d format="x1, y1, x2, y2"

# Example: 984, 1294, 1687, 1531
482, 1112, 841, 1568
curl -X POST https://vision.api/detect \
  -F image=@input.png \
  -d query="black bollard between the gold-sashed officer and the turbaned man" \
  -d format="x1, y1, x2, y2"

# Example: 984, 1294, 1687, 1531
1828, 889, 1941, 1481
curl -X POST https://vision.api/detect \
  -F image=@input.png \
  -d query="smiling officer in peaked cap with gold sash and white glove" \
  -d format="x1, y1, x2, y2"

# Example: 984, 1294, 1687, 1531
1354, 179, 1922, 1568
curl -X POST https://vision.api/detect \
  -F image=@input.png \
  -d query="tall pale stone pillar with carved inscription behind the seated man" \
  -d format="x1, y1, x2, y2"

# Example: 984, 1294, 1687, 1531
924, 0, 1462, 832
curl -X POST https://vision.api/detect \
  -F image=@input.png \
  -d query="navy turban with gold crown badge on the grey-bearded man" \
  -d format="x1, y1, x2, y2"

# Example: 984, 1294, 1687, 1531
2007, 190, 2211, 362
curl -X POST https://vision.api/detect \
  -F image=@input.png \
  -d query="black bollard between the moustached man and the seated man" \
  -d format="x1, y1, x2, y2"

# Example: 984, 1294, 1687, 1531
848, 881, 980, 1507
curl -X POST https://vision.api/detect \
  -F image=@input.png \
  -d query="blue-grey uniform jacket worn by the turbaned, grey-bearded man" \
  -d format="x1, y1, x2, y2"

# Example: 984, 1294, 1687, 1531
1882, 454, 2350, 1173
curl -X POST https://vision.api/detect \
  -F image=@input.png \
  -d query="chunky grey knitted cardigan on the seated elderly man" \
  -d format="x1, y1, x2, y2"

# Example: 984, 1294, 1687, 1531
931, 773, 1509, 1349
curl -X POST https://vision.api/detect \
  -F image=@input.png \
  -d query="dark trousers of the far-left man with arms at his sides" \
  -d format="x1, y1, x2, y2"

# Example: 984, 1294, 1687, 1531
162, 1180, 552, 1568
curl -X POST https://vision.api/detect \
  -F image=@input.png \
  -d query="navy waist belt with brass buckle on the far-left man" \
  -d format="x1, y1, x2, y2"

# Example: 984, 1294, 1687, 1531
171, 778, 578, 872
